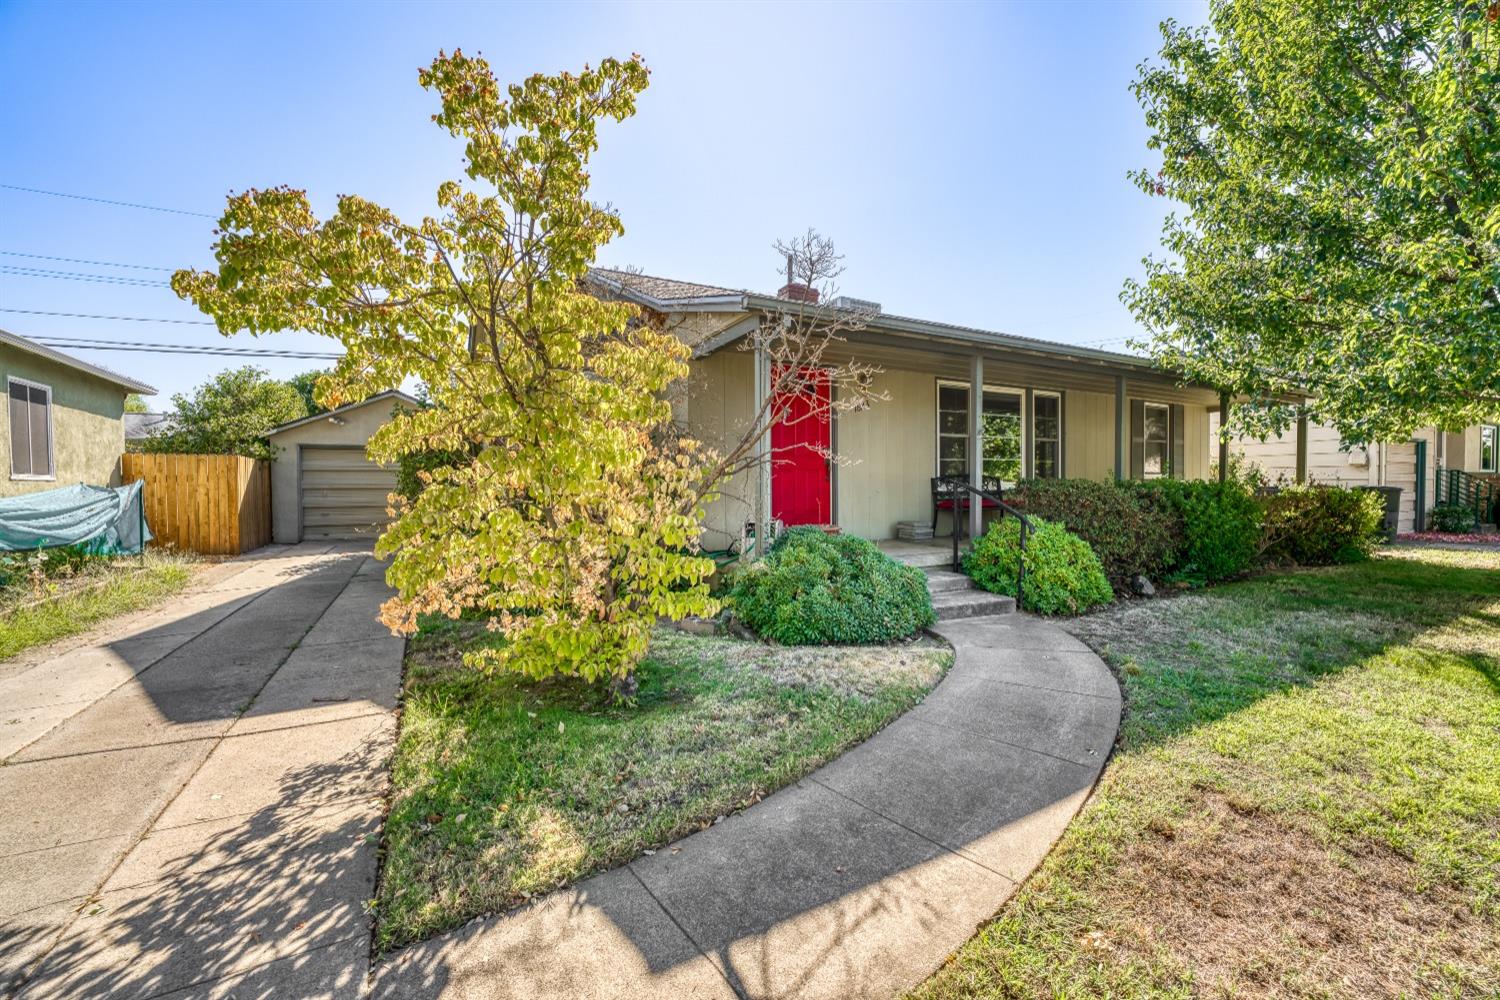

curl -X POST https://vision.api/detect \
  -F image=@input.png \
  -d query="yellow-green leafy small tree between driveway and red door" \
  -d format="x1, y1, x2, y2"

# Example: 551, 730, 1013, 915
173, 51, 869, 696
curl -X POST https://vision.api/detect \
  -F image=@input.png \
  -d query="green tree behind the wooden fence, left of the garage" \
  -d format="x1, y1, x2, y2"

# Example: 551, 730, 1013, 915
141, 364, 308, 459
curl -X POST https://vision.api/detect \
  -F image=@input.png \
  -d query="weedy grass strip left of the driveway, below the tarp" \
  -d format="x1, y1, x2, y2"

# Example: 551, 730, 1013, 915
0, 549, 192, 660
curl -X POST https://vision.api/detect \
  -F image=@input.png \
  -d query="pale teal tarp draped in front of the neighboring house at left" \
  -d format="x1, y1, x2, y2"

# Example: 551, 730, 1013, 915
0, 483, 152, 555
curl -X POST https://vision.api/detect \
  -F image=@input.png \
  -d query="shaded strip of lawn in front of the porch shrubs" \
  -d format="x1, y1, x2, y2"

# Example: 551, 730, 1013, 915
1064, 549, 1500, 750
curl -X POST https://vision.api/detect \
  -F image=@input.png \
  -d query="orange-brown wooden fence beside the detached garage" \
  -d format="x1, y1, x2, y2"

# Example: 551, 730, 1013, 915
120, 453, 272, 556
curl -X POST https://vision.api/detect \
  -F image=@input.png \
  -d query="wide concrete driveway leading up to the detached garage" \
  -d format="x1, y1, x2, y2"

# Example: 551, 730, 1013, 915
0, 544, 404, 997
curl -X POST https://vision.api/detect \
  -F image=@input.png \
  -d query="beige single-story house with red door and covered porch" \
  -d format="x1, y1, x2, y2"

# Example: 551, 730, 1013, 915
591, 268, 1248, 549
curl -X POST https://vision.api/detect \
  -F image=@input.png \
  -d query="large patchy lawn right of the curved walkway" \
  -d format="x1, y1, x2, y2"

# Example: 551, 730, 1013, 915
914, 549, 1500, 1000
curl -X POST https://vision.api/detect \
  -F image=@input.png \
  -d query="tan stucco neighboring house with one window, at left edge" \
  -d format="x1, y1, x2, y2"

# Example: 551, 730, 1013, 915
0, 330, 156, 496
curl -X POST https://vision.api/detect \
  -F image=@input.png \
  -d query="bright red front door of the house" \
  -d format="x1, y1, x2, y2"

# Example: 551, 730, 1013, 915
771, 369, 834, 525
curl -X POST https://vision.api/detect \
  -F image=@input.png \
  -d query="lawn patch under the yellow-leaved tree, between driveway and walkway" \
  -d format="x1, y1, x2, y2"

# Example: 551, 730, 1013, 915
375, 621, 953, 951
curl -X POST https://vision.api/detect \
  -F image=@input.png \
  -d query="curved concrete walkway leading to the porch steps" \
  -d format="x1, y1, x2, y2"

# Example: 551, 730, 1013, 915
374, 615, 1121, 1000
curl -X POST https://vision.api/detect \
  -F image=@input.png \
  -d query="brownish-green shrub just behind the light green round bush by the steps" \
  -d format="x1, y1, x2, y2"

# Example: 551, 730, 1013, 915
1013, 480, 1182, 591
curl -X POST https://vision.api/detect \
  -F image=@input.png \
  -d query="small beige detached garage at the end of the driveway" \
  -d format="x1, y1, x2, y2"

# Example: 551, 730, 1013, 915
270, 391, 420, 544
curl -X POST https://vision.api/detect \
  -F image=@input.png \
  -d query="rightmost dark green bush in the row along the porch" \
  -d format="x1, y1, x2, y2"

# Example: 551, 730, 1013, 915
1260, 486, 1386, 565
